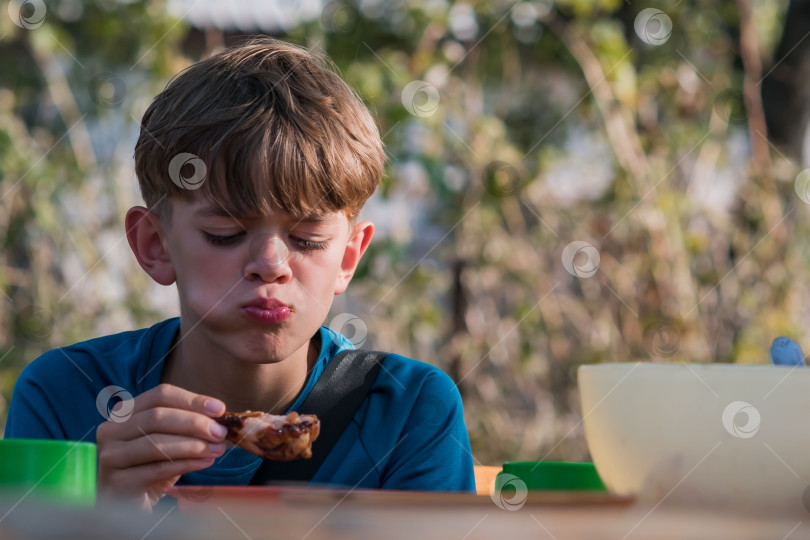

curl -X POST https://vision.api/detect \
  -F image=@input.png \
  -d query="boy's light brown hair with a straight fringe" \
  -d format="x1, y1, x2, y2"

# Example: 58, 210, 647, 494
135, 38, 385, 222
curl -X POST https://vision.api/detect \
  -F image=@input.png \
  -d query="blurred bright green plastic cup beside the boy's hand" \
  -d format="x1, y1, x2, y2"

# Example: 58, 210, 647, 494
0, 439, 96, 507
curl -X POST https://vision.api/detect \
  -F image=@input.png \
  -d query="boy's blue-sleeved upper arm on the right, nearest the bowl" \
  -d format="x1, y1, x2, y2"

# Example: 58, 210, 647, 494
380, 371, 475, 491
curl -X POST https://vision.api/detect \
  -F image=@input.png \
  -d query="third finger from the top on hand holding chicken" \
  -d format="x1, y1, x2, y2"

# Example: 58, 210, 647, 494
98, 434, 225, 469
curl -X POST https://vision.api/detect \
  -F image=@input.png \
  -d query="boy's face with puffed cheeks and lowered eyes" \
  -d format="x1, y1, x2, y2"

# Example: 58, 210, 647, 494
153, 200, 373, 363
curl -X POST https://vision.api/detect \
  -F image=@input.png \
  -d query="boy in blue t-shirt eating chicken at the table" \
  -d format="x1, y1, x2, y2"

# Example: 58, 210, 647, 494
6, 39, 474, 508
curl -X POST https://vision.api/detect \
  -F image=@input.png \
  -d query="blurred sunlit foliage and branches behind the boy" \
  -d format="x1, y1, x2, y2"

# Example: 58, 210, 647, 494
0, 0, 810, 464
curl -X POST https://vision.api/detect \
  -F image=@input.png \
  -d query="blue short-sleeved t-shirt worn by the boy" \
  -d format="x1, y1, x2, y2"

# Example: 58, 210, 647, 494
5, 318, 475, 491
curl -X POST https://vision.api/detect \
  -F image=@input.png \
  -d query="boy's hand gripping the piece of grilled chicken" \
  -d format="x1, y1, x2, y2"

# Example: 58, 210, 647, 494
96, 384, 228, 510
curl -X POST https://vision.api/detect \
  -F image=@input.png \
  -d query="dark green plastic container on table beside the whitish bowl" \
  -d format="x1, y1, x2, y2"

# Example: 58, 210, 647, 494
495, 461, 607, 491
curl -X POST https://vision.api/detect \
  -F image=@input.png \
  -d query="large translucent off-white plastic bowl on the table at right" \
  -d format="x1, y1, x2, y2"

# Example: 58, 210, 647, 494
578, 363, 810, 516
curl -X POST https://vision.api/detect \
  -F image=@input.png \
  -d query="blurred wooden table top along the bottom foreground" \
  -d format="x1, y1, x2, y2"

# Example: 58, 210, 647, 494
0, 487, 810, 540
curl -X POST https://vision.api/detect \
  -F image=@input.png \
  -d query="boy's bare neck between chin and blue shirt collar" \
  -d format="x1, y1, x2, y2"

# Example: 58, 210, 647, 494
160, 324, 321, 414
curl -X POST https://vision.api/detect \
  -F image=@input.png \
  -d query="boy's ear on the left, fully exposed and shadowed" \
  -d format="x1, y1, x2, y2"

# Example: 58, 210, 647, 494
125, 206, 177, 285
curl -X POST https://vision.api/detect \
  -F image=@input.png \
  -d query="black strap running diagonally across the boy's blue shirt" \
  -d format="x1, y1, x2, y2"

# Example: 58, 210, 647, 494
250, 349, 388, 485
